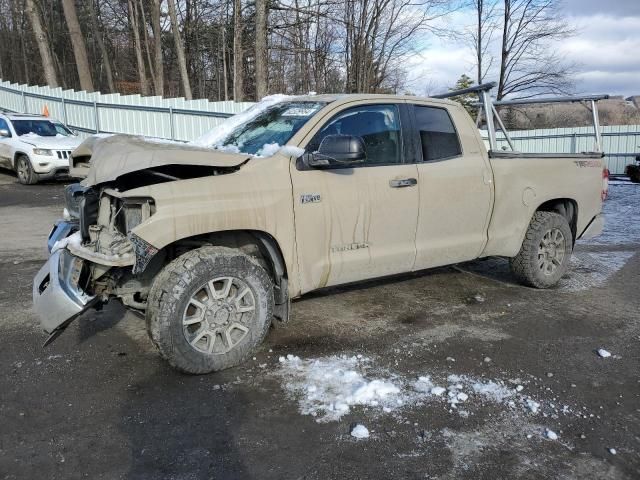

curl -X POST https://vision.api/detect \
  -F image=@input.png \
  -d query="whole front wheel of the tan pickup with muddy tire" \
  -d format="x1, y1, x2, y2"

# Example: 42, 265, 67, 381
147, 246, 273, 374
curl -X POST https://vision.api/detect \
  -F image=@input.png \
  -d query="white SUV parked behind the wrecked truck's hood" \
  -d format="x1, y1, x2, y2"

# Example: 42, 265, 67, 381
0, 113, 82, 185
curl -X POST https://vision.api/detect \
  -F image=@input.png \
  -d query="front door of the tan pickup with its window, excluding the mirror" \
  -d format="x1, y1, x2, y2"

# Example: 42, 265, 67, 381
291, 103, 419, 293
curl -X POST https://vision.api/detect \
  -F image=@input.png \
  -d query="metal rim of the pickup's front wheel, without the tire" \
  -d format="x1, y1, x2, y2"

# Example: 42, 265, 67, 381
182, 277, 256, 355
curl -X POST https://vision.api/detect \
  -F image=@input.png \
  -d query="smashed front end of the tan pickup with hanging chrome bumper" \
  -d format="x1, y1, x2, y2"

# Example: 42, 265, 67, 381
33, 184, 158, 345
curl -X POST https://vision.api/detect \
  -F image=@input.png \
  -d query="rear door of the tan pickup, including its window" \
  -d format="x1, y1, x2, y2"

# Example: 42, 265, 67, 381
410, 103, 493, 270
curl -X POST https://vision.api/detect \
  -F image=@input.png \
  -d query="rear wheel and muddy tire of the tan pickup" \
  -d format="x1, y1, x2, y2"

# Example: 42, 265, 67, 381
510, 212, 573, 288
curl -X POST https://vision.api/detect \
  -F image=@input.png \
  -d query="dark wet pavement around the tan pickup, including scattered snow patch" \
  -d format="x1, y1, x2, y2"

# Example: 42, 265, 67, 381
0, 172, 640, 479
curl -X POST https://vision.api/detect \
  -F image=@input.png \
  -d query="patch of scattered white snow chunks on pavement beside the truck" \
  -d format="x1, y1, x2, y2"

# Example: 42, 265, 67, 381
275, 355, 586, 422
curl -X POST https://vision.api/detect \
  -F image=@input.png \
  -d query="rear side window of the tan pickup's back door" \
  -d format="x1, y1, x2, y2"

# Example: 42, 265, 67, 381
414, 105, 462, 162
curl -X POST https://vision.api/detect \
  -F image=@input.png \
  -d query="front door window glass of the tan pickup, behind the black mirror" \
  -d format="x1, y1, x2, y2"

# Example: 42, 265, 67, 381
307, 105, 402, 165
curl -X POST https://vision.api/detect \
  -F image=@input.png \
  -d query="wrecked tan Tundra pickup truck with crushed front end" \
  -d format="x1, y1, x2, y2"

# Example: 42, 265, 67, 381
33, 91, 603, 373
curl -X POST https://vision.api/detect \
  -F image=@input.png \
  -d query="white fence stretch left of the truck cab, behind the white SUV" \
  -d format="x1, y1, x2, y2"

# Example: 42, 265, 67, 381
0, 80, 253, 141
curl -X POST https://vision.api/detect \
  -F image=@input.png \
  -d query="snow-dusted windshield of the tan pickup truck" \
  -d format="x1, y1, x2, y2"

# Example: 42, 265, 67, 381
216, 102, 325, 156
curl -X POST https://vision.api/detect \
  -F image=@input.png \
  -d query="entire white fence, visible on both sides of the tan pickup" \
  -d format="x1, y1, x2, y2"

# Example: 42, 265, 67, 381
0, 80, 640, 175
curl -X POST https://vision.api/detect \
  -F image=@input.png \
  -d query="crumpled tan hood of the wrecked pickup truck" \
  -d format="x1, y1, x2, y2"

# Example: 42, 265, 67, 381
69, 135, 251, 186
